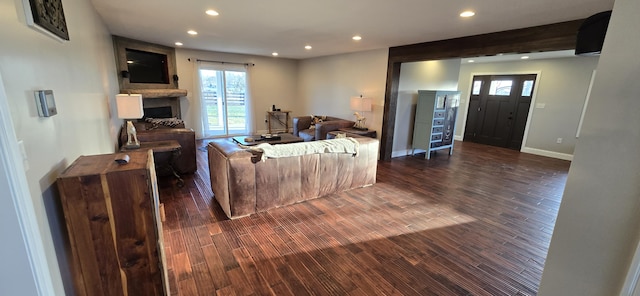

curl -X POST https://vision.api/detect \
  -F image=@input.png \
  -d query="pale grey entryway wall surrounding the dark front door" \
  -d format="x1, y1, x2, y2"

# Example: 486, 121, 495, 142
456, 57, 598, 159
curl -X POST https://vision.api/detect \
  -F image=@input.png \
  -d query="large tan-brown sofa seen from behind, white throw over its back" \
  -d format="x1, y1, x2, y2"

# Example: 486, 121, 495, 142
207, 138, 379, 219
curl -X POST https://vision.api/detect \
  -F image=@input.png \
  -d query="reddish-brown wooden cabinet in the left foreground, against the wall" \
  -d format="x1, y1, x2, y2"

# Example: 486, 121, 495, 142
57, 150, 169, 296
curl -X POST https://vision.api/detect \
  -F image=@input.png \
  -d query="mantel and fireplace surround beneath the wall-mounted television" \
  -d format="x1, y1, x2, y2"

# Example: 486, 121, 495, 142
120, 89, 187, 119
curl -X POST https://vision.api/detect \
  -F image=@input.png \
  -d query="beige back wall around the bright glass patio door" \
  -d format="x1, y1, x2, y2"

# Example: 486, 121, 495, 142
176, 49, 301, 138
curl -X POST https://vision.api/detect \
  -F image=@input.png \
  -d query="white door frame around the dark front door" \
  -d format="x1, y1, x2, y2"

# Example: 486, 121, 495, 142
455, 70, 542, 151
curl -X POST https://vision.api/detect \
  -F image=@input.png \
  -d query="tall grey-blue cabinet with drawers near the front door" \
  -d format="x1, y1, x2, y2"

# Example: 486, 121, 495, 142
411, 90, 460, 159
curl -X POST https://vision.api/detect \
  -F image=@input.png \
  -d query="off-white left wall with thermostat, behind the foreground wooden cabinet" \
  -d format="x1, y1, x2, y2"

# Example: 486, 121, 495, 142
0, 0, 120, 295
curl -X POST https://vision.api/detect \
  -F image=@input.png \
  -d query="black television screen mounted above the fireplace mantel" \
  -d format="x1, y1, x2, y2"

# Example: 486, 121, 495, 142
126, 48, 169, 84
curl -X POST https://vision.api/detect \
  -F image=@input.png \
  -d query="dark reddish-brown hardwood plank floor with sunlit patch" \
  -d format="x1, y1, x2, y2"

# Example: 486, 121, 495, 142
159, 141, 570, 295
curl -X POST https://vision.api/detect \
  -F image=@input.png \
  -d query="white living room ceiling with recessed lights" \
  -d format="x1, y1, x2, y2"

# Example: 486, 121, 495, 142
91, 0, 614, 59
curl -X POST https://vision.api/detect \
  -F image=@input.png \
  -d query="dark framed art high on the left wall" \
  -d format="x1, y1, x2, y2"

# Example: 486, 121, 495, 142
23, 0, 69, 40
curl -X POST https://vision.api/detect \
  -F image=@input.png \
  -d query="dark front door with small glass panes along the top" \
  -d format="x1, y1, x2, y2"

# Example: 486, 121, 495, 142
464, 74, 536, 150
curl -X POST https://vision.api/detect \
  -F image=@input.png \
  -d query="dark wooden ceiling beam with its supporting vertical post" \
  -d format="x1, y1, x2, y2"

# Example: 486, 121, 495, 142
380, 19, 584, 160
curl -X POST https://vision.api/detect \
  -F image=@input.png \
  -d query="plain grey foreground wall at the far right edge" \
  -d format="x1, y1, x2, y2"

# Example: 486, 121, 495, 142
539, 0, 640, 296
